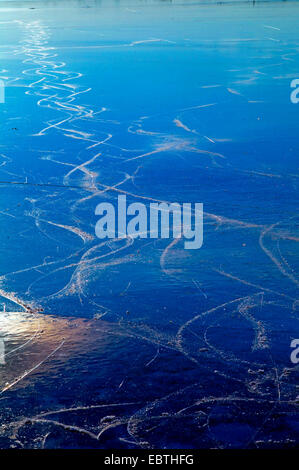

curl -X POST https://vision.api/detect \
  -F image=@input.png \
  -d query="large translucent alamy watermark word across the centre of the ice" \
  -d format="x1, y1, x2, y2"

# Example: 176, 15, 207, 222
95, 195, 203, 250
